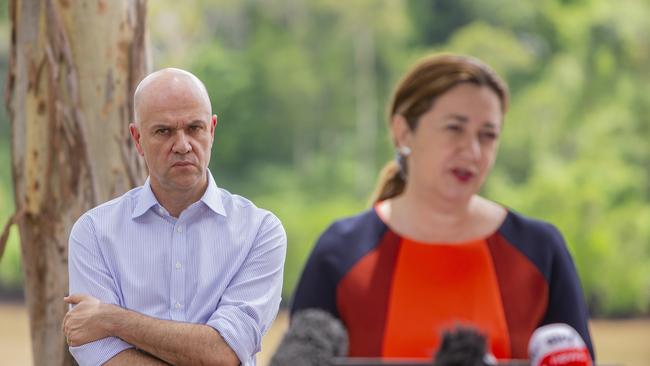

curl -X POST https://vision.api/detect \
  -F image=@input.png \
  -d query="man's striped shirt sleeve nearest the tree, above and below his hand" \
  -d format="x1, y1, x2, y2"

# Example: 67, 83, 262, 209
68, 215, 133, 366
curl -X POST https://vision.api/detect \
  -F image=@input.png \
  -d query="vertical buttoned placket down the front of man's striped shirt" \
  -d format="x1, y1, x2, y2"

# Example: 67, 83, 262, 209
170, 221, 187, 321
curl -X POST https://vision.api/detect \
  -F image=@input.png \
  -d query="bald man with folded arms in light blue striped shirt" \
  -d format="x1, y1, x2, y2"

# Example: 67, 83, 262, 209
63, 69, 286, 365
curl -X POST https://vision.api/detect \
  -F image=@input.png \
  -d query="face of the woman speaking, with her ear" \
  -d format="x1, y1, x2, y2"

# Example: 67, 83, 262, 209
392, 83, 503, 201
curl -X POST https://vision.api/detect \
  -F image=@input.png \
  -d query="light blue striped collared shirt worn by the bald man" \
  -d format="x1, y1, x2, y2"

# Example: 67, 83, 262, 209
68, 172, 287, 365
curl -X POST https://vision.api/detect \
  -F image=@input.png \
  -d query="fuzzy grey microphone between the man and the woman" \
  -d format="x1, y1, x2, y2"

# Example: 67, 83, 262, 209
270, 309, 348, 366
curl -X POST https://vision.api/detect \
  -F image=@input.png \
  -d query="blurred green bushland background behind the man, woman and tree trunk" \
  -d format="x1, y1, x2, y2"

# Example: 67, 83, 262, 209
0, 0, 650, 365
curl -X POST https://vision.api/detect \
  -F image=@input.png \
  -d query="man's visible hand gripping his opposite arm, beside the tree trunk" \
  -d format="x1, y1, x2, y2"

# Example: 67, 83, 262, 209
63, 294, 110, 347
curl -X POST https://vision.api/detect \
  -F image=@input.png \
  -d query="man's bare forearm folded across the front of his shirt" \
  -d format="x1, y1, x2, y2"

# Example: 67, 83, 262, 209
108, 305, 239, 366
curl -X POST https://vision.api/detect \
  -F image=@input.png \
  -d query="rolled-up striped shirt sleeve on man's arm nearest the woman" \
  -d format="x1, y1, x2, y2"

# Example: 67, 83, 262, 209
207, 213, 287, 365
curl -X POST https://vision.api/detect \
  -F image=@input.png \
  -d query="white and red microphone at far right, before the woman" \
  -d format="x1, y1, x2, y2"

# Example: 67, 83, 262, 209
528, 323, 592, 366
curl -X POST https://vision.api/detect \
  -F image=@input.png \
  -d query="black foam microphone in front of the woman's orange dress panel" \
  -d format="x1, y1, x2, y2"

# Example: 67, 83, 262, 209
433, 326, 496, 366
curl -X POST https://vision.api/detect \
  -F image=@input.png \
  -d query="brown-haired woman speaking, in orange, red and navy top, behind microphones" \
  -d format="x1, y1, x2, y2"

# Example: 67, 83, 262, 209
291, 55, 593, 359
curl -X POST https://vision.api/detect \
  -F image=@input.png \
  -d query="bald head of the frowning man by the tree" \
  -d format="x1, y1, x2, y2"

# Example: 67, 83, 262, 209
129, 68, 217, 198
